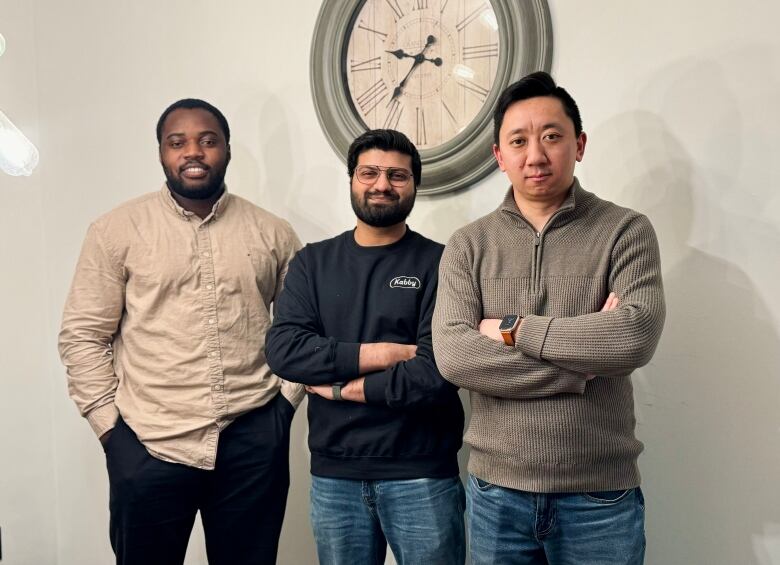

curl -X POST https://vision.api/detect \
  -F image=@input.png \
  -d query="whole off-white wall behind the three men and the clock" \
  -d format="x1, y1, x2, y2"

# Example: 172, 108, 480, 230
0, 0, 780, 565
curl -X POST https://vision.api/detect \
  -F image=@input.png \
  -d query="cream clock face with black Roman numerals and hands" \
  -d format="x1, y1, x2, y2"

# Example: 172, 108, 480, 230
342, 0, 501, 149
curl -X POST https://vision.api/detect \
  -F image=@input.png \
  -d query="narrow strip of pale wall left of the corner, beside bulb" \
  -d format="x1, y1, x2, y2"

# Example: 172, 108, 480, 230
0, 0, 58, 563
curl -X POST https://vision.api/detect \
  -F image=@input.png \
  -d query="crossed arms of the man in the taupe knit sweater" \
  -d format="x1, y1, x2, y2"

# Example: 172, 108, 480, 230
434, 216, 664, 398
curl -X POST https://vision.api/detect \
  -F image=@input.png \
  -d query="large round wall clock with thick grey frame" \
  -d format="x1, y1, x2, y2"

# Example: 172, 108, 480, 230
311, 0, 552, 194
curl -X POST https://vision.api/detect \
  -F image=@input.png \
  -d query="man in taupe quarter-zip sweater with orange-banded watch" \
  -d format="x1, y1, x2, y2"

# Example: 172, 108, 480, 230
433, 72, 665, 565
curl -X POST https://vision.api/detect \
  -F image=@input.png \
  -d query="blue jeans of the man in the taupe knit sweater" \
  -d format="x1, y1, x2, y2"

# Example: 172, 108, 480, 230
467, 475, 645, 565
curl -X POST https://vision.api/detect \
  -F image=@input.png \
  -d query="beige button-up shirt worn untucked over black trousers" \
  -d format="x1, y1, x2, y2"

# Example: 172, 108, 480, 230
59, 185, 304, 469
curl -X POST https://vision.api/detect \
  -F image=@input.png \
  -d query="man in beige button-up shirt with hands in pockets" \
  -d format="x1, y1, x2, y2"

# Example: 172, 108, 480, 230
59, 99, 303, 564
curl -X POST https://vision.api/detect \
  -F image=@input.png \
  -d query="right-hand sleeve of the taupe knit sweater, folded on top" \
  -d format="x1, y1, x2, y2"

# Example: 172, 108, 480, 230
516, 215, 666, 376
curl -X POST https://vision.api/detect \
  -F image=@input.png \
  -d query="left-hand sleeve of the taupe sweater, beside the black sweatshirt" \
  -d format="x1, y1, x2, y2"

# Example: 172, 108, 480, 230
433, 234, 586, 399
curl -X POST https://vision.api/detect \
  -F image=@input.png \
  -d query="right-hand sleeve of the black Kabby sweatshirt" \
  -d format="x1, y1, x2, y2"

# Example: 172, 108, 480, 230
363, 264, 458, 408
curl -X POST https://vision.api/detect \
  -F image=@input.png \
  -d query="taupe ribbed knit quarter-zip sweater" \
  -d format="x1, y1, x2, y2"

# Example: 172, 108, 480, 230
433, 179, 665, 493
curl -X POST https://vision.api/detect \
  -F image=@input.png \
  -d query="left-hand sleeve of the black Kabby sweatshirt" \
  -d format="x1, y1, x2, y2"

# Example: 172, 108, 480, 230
265, 248, 360, 385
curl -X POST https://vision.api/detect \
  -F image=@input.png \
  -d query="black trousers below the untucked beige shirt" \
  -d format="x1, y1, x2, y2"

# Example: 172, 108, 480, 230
104, 394, 294, 565
